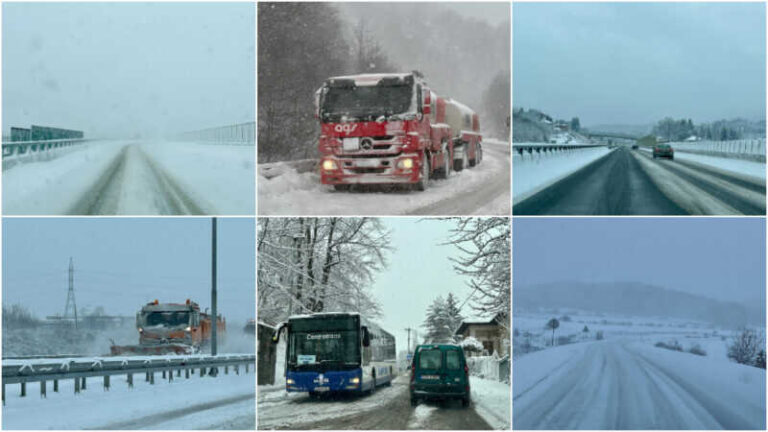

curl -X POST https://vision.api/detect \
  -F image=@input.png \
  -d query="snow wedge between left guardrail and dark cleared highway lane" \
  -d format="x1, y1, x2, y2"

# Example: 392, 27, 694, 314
512, 147, 611, 203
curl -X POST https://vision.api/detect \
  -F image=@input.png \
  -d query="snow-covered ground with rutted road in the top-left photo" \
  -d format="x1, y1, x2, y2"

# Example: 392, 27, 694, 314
3, 141, 255, 215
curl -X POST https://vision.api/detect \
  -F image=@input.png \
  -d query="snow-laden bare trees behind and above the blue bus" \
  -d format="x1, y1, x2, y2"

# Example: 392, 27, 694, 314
257, 218, 390, 322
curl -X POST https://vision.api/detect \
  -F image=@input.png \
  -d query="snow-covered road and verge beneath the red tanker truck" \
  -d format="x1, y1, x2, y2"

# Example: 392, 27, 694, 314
258, 140, 511, 216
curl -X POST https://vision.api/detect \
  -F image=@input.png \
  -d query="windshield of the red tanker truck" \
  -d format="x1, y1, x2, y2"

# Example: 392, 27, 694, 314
321, 84, 413, 122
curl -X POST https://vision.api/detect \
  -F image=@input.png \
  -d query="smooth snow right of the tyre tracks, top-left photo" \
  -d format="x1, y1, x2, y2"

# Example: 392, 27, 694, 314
142, 142, 256, 215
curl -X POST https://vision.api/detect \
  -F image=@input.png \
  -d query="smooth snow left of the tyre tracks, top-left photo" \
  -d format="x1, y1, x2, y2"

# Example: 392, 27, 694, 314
3, 141, 126, 215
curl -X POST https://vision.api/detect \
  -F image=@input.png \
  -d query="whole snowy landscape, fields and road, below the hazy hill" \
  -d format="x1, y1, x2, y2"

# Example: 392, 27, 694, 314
513, 311, 765, 429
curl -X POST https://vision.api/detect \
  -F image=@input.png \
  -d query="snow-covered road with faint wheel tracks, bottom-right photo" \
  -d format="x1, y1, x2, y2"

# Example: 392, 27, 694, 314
513, 340, 765, 430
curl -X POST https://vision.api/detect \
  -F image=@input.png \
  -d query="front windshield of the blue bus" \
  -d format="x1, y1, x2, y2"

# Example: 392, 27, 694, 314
288, 330, 360, 370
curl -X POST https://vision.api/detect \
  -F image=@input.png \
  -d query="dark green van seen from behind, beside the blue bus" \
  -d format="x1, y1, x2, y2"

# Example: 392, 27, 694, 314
410, 344, 470, 407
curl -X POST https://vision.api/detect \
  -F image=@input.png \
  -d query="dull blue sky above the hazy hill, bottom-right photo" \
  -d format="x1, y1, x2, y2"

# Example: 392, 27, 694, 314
512, 218, 765, 306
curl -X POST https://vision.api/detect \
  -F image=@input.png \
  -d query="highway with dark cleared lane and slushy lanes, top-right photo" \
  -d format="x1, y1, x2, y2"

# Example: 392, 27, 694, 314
513, 147, 766, 215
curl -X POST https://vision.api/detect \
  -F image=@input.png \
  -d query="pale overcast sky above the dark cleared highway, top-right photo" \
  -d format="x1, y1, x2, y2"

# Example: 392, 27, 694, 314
512, 2, 766, 126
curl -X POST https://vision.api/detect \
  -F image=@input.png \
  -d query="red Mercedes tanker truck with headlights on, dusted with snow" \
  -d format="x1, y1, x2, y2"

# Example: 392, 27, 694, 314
315, 72, 482, 191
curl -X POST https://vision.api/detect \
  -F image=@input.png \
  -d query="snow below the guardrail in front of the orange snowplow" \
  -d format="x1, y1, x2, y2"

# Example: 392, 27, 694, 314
3, 369, 255, 430
